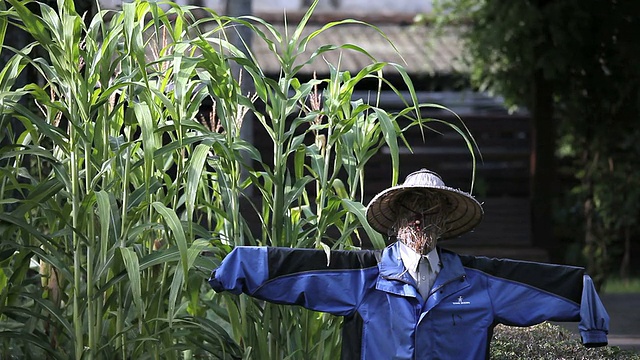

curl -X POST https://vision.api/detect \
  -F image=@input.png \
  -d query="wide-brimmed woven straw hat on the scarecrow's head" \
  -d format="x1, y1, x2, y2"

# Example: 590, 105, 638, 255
367, 169, 484, 239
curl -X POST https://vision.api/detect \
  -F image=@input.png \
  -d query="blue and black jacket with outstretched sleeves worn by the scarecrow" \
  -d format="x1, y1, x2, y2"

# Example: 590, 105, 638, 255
209, 243, 609, 360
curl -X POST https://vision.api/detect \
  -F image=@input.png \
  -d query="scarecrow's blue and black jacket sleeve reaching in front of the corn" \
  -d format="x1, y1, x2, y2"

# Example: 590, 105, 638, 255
209, 246, 377, 315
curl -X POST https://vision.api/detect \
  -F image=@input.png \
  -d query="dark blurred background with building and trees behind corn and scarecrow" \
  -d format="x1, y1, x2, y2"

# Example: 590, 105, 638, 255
3, 0, 640, 285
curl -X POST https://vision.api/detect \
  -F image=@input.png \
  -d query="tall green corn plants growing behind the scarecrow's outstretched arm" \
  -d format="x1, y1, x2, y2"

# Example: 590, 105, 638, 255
0, 0, 473, 359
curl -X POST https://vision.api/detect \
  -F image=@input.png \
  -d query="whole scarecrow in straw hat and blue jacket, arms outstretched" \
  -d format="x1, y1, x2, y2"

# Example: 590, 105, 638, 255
209, 169, 609, 360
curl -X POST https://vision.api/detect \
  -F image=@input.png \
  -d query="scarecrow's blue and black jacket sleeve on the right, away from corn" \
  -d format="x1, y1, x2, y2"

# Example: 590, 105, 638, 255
464, 258, 609, 347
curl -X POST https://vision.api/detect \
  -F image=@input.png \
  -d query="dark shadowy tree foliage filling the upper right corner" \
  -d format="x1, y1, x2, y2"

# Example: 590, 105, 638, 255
438, 0, 640, 283
